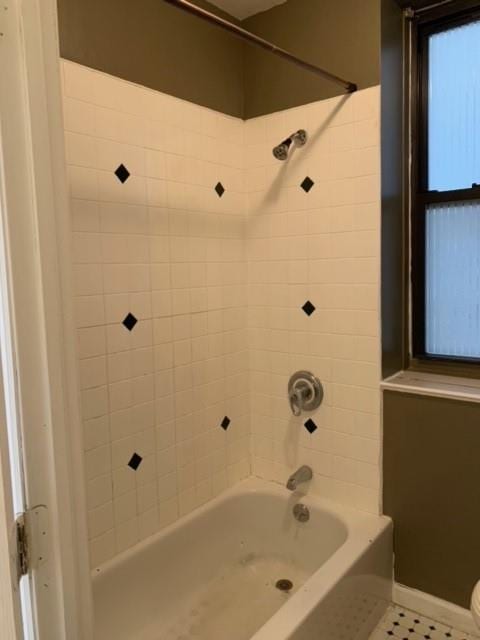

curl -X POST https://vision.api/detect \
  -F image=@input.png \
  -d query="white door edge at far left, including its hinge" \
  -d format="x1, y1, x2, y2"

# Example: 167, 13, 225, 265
0, 171, 49, 640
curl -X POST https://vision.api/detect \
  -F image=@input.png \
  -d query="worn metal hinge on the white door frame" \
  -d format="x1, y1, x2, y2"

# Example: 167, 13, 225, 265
15, 505, 48, 582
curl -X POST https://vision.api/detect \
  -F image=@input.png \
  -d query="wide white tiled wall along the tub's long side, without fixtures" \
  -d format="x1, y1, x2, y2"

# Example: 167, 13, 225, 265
63, 62, 250, 566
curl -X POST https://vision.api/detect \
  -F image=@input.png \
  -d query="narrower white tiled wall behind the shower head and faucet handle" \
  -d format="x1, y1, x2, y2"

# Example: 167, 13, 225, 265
245, 87, 380, 512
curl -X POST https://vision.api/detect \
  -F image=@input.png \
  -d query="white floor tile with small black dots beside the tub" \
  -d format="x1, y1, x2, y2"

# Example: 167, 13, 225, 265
370, 605, 478, 640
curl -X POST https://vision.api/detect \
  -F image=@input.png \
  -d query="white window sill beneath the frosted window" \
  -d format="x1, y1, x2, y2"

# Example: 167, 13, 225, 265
380, 371, 480, 402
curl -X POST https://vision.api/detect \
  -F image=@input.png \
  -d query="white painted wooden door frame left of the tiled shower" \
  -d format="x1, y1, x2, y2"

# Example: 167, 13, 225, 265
0, 0, 93, 640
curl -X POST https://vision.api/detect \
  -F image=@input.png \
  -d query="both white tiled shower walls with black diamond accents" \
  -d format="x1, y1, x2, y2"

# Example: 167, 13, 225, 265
63, 61, 380, 566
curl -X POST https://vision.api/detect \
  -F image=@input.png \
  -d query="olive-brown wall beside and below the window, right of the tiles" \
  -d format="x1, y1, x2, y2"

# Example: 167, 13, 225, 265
382, 0, 480, 607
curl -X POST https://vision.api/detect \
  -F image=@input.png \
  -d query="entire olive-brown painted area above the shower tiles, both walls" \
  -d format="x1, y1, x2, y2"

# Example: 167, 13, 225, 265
58, 0, 380, 118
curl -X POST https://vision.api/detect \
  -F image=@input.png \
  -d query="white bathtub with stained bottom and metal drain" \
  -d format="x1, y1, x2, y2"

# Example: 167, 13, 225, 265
93, 479, 392, 640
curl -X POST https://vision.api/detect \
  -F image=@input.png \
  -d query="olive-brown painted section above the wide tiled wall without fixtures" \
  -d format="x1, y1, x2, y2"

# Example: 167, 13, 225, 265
58, 0, 244, 116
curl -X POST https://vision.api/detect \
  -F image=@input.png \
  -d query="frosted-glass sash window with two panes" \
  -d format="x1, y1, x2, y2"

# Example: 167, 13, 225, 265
411, 3, 480, 373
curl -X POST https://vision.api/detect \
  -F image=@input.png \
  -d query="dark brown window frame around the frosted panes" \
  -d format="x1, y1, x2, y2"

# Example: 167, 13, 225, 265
406, 0, 480, 378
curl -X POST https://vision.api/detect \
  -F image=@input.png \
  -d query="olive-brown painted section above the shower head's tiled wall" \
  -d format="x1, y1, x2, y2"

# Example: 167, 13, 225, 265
243, 0, 380, 118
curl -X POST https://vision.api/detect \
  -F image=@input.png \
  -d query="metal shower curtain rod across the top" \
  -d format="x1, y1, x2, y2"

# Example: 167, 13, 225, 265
164, 0, 358, 93
